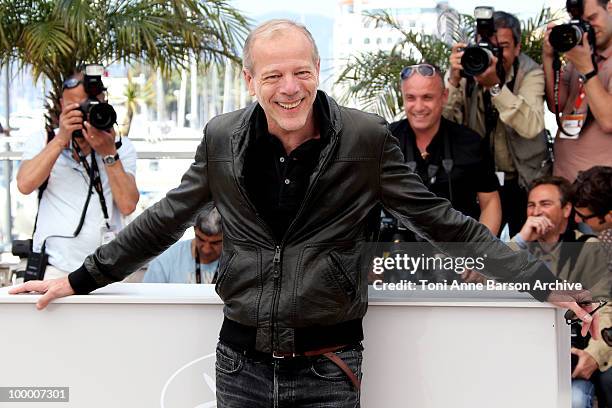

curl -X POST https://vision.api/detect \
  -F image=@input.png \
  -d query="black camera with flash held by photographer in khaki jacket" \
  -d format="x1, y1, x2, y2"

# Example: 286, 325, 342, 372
461, 7, 500, 76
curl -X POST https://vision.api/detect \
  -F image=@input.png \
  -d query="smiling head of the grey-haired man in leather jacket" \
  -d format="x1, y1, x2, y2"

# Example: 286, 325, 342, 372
243, 27, 319, 136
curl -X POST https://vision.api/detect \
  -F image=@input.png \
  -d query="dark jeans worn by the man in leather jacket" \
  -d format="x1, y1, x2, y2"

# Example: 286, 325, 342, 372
216, 343, 362, 408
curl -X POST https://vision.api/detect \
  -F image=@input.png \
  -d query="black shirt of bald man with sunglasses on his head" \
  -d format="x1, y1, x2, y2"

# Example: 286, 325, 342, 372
389, 118, 499, 219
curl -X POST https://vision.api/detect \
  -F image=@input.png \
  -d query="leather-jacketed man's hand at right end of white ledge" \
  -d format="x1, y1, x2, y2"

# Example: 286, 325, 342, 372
546, 290, 600, 340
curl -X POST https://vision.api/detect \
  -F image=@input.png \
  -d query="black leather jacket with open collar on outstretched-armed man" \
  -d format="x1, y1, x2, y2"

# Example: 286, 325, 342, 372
70, 94, 554, 352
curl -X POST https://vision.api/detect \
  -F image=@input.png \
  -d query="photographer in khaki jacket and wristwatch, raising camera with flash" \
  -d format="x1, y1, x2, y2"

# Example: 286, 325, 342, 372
443, 8, 549, 236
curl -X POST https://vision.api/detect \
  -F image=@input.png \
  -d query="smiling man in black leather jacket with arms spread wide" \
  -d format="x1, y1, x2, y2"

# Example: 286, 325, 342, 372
11, 20, 597, 407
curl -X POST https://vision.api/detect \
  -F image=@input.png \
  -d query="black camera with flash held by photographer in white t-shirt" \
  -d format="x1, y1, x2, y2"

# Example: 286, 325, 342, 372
72, 64, 117, 137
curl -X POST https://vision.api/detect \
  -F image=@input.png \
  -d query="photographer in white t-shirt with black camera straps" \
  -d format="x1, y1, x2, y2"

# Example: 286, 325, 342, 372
17, 73, 139, 278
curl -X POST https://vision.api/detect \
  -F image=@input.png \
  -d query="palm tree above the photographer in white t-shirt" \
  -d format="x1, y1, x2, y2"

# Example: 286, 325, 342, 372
0, 0, 249, 137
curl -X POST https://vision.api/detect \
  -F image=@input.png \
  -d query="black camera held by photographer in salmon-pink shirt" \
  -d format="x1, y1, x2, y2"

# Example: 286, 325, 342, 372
549, 0, 595, 52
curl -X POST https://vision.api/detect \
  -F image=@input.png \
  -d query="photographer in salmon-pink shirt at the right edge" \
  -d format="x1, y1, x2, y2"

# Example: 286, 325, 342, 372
542, 0, 612, 181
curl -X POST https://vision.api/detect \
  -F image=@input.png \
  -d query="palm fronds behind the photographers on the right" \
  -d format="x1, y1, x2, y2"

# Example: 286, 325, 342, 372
336, 8, 559, 120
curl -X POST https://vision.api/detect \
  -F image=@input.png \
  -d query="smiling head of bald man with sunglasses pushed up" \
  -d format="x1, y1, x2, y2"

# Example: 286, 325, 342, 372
402, 73, 448, 134
